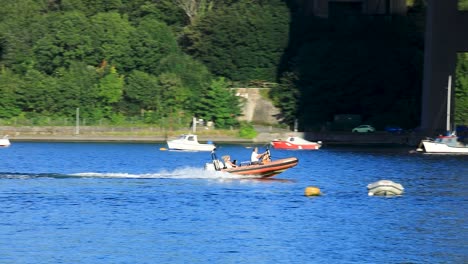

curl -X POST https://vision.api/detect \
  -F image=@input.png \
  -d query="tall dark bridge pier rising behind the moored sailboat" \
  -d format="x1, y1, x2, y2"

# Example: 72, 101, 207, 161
421, 0, 468, 133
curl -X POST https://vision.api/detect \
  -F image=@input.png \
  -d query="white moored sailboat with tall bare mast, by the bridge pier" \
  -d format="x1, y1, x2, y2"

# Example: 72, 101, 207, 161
416, 76, 468, 154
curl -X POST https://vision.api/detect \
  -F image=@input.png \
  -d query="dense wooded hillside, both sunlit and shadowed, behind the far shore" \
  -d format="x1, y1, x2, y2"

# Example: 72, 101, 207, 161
0, 0, 468, 130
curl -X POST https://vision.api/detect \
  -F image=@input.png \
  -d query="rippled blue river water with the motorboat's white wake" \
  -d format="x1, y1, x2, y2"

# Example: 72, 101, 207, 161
0, 142, 468, 263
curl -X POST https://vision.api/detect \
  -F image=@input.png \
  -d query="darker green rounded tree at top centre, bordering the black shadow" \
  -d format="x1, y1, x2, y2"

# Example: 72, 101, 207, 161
186, 0, 290, 82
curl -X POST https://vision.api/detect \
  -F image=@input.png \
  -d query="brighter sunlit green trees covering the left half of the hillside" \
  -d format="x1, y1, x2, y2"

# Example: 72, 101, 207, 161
0, 0, 245, 127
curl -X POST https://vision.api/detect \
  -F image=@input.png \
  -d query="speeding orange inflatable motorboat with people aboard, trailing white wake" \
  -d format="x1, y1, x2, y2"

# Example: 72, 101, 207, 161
205, 149, 299, 178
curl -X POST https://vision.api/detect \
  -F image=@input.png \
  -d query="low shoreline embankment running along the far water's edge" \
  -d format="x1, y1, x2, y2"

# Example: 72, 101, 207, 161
0, 126, 424, 147
